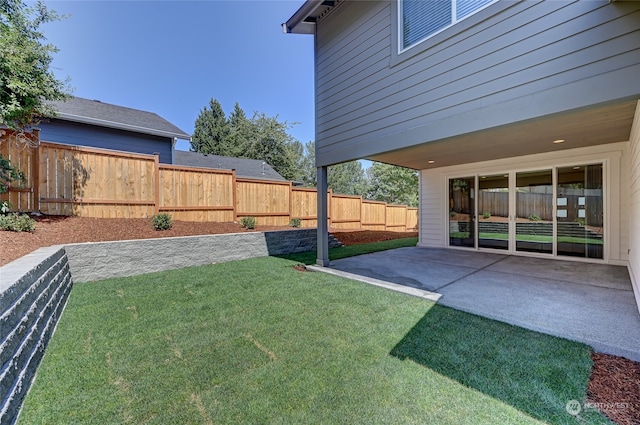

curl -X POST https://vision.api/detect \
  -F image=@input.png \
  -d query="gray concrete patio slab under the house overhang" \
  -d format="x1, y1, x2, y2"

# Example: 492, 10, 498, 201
322, 247, 640, 361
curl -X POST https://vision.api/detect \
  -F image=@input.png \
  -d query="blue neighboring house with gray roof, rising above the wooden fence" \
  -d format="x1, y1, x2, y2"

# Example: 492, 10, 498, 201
39, 97, 191, 164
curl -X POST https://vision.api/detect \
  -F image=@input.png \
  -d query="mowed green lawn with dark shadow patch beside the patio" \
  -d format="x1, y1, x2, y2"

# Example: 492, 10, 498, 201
19, 253, 607, 425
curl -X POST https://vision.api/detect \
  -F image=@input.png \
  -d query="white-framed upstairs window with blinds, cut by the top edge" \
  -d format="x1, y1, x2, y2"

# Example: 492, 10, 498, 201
398, 0, 496, 51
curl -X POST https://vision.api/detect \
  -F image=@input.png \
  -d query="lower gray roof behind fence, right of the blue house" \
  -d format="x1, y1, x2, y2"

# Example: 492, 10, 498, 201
173, 151, 286, 181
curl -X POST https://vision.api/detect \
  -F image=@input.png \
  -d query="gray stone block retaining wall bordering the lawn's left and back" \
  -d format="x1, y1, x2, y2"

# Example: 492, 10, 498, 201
0, 229, 340, 424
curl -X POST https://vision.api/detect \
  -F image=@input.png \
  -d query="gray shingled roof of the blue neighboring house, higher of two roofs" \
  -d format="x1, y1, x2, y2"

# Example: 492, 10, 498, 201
51, 97, 191, 140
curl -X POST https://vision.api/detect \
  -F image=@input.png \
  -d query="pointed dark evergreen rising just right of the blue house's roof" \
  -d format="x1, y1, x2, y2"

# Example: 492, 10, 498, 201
191, 98, 234, 156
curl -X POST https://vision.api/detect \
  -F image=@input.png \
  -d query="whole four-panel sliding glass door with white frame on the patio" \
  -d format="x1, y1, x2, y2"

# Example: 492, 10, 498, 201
449, 163, 604, 259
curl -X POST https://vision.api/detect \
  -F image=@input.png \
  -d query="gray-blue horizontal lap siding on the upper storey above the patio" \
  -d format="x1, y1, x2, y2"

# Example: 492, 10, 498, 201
316, 1, 640, 166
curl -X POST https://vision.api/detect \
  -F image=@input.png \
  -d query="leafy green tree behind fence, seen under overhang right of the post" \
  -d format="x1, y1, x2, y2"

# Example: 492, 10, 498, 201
367, 162, 418, 207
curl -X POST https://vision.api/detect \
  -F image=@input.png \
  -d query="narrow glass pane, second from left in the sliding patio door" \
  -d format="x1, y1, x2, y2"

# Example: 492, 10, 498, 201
478, 174, 509, 250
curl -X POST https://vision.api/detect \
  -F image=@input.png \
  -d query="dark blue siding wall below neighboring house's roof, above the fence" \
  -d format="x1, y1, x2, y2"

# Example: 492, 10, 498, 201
39, 120, 173, 164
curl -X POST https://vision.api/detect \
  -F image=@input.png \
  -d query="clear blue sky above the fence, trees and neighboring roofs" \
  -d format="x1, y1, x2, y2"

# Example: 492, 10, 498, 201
44, 0, 314, 150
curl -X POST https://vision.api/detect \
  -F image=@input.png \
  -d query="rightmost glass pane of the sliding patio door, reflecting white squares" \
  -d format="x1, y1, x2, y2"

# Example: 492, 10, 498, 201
556, 164, 604, 258
